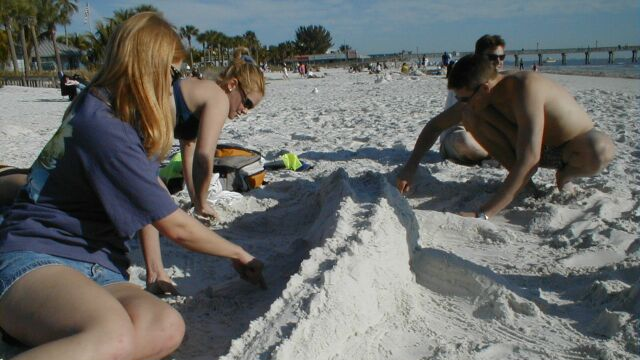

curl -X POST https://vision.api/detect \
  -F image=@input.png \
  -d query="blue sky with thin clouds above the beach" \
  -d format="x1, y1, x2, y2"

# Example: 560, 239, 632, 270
59, 0, 640, 54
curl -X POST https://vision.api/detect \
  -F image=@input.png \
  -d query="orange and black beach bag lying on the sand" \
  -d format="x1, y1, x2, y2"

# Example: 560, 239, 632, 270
213, 144, 266, 192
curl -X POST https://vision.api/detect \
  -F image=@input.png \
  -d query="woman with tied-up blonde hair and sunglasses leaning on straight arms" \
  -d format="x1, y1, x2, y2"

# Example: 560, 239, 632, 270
173, 48, 265, 216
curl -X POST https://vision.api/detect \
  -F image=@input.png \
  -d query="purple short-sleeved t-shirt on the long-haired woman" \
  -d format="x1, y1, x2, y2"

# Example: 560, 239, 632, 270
0, 92, 177, 275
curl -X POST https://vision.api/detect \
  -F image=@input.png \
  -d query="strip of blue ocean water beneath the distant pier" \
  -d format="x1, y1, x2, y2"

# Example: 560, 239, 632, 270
504, 56, 640, 79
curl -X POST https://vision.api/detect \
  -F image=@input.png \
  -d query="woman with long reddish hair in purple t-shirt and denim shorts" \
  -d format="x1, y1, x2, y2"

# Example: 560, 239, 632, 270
0, 13, 262, 359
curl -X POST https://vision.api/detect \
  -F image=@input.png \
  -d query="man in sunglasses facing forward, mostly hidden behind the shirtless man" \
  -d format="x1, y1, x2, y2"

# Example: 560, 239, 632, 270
440, 34, 505, 165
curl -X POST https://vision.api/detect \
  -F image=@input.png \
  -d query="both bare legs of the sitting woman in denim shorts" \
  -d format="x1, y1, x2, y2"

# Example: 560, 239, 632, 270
0, 265, 184, 359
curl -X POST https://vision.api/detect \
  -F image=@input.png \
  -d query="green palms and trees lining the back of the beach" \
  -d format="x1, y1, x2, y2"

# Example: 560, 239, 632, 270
0, 0, 344, 78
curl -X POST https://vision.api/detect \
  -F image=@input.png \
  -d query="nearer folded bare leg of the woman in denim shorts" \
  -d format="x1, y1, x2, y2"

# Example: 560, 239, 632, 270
0, 265, 134, 360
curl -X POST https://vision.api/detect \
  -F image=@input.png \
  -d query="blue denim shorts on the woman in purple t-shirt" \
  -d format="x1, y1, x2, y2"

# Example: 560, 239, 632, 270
0, 251, 127, 297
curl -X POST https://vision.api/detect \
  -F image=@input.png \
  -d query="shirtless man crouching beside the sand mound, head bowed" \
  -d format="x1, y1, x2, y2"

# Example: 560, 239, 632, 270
397, 55, 615, 219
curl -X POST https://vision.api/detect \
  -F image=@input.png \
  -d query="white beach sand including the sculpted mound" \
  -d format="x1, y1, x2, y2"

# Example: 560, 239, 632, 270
0, 70, 640, 359
